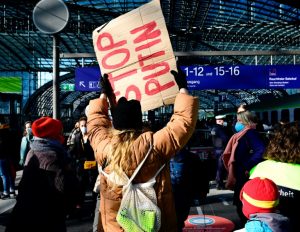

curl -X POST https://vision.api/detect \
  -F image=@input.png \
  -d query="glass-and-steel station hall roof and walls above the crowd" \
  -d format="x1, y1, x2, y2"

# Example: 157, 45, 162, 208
0, 0, 300, 130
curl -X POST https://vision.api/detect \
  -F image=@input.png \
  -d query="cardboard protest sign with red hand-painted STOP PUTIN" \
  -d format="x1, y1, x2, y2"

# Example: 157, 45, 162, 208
93, 0, 178, 111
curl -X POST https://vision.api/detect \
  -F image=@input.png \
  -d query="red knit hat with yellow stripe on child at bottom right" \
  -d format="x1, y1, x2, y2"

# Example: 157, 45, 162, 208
240, 177, 279, 218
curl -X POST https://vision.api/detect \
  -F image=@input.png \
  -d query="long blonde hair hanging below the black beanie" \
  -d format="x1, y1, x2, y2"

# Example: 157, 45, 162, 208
108, 129, 141, 175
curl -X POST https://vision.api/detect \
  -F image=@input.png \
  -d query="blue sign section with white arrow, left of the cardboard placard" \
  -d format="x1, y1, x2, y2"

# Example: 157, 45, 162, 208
75, 67, 101, 91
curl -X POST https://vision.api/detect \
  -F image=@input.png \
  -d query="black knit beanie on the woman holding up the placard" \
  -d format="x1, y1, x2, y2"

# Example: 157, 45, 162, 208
112, 97, 143, 130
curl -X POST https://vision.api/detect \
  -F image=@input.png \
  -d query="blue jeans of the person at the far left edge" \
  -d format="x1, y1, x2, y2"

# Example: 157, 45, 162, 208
0, 159, 15, 194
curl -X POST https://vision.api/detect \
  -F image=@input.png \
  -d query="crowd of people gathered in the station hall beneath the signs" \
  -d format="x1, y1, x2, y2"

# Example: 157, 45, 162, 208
0, 67, 300, 232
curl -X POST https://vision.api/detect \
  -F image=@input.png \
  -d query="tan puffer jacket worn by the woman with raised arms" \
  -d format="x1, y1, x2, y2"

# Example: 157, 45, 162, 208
87, 93, 198, 232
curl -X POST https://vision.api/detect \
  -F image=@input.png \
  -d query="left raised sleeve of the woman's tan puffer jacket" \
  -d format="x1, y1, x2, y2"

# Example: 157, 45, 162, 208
87, 98, 111, 164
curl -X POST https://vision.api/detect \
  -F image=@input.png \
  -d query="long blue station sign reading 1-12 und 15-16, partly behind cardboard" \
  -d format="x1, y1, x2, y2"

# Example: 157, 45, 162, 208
75, 65, 300, 91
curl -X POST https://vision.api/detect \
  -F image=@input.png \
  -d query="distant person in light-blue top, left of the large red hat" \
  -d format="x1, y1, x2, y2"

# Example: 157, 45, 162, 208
19, 121, 33, 166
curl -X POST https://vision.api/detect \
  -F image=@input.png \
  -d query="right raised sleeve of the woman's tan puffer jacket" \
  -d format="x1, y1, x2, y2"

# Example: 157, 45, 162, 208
153, 93, 198, 159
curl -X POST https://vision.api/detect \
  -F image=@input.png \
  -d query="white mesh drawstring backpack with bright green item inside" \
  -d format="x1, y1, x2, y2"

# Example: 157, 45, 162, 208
101, 144, 165, 232
